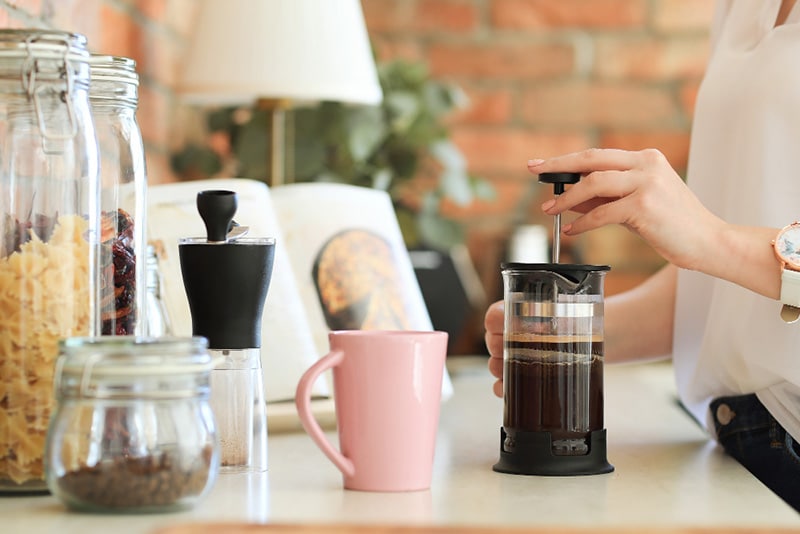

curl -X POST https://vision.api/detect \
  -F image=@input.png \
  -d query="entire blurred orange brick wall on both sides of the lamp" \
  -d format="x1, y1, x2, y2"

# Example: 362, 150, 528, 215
0, 0, 713, 356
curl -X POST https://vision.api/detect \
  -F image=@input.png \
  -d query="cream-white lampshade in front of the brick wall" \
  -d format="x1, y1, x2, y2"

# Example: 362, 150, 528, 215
178, 0, 382, 104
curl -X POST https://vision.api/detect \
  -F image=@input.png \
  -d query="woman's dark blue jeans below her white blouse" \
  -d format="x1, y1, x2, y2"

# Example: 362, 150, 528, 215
711, 394, 800, 512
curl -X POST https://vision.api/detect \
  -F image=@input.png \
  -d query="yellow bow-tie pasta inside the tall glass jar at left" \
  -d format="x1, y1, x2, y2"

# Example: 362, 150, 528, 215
0, 215, 91, 486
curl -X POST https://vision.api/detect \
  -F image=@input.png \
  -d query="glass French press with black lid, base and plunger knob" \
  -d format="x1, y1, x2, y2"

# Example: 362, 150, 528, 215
494, 173, 614, 475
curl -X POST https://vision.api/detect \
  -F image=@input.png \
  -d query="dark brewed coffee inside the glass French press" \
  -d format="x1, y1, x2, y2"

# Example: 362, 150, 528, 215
503, 334, 603, 454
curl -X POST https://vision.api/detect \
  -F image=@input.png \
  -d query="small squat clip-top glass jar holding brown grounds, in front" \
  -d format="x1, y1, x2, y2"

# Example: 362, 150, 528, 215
47, 336, 220, 512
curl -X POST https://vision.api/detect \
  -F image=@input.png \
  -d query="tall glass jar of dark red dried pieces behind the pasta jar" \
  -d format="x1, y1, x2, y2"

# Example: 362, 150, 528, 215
89, 55, 147, 335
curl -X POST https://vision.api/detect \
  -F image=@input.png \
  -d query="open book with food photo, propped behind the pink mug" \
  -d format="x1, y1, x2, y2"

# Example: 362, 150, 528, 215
147, 182, 452, 430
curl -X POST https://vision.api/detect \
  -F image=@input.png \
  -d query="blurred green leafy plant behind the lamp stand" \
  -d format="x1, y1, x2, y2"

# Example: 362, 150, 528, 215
172, 61, 494, 250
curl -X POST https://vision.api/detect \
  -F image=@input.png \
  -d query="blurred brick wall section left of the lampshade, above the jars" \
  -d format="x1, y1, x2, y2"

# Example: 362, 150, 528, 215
0, 0, 195, 188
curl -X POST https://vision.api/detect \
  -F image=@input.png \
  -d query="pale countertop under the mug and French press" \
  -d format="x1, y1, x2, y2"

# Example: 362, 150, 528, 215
0, 358, 800, 534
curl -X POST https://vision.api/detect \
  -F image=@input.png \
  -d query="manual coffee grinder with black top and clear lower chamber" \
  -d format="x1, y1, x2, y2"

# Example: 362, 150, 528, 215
178, 190, 275, 473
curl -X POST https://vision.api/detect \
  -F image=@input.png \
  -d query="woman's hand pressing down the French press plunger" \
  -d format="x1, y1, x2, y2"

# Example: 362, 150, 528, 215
528, 149, 725, 269
